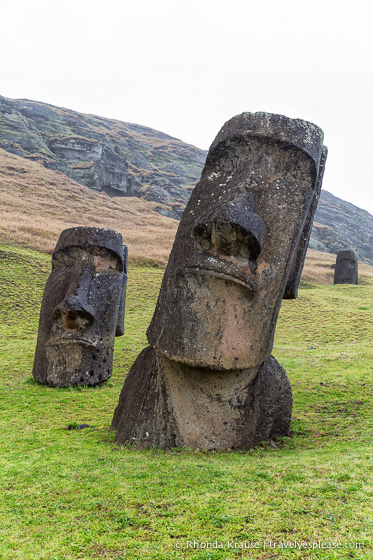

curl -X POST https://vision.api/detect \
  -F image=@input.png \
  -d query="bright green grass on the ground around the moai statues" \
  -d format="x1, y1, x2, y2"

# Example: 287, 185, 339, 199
0, 246, 373, 560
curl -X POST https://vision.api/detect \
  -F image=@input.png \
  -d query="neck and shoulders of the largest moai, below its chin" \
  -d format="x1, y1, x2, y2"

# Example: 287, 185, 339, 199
111, 347, 292, 450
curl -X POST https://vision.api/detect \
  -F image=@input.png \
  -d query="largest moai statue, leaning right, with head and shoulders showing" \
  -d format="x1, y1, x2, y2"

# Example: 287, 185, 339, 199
112, 113, 326, 449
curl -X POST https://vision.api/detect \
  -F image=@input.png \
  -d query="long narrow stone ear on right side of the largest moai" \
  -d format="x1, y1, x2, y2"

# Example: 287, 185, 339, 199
283, 146, 328, 299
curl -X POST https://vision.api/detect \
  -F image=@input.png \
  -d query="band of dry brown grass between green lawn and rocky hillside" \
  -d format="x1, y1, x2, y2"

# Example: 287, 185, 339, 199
0, 149, 373, 284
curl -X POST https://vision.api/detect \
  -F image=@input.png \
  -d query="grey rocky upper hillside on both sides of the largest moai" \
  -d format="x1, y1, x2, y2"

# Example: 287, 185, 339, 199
0, 96, 373, 264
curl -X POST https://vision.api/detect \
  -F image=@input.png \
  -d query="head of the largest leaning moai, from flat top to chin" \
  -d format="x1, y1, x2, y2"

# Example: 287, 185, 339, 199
147, 113, 326, 371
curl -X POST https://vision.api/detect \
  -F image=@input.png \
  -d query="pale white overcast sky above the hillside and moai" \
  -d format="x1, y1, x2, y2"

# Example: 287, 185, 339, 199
0, 0, 373, 213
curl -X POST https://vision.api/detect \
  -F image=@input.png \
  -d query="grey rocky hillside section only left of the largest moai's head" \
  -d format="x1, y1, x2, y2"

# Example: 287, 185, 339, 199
0, 96, 206, 210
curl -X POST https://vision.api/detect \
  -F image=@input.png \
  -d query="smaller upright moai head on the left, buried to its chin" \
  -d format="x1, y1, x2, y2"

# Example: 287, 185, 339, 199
32, 227, 127, 387
